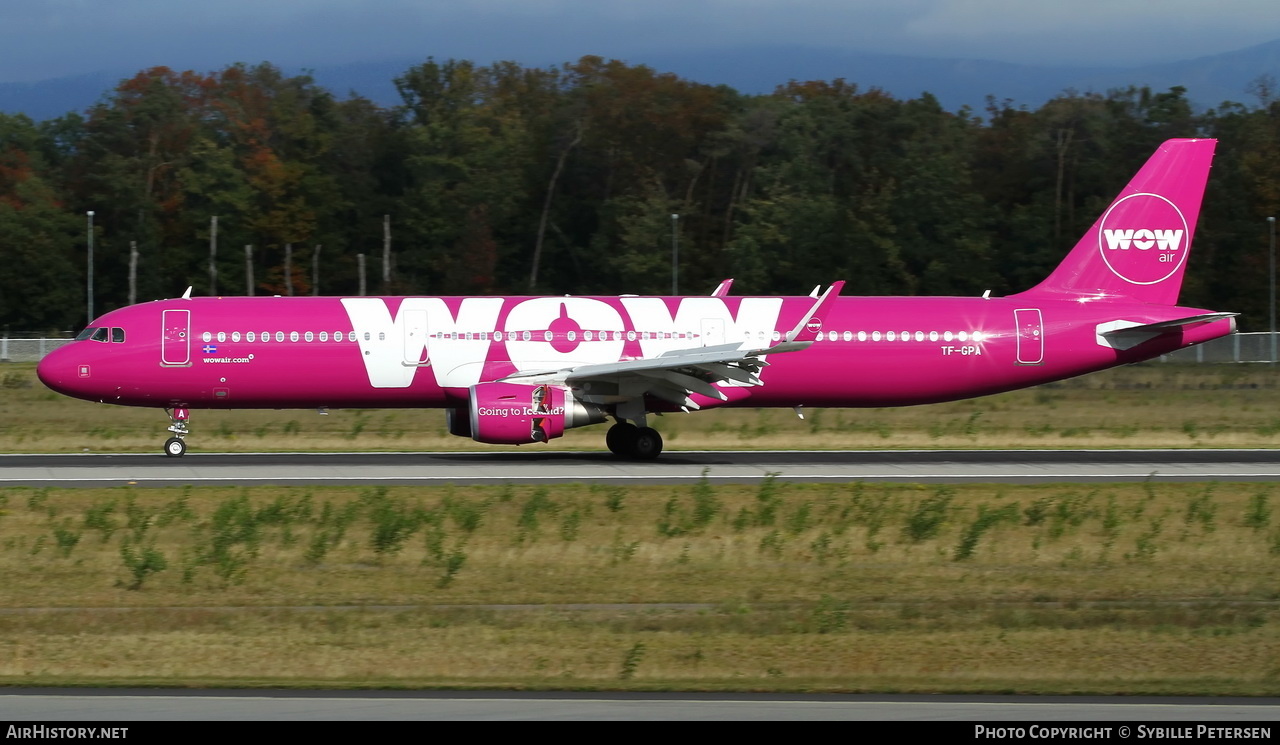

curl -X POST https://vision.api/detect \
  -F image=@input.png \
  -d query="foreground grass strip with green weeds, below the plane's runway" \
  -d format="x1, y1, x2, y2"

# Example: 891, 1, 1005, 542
0, 480, 1280, 695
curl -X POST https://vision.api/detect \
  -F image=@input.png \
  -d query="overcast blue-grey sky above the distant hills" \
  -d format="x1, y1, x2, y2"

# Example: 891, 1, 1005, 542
0, 0, 1280, 82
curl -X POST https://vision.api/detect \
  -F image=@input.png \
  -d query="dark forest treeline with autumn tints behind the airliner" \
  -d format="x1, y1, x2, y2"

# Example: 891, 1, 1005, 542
0, 56, 1280, 335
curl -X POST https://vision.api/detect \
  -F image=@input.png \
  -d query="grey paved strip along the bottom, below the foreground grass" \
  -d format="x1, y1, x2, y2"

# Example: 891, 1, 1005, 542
0, 689, 1280, 721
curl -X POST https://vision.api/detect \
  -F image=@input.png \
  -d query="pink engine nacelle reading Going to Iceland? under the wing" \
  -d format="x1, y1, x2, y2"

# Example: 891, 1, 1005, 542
463, 383, 605, 445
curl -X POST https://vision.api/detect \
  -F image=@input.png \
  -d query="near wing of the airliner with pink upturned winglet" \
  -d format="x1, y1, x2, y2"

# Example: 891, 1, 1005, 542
503, 282, 845, 410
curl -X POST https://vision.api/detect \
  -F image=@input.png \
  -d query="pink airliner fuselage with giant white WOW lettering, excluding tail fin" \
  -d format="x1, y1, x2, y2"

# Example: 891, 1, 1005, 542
32, 296, 1233, 411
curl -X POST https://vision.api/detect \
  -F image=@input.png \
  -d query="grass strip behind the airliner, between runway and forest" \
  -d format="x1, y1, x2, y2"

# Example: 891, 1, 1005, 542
0, 364, 1280, 453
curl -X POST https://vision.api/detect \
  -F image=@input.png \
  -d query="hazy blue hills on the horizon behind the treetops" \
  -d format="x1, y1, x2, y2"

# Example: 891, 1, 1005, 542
0, 40, 1280, 120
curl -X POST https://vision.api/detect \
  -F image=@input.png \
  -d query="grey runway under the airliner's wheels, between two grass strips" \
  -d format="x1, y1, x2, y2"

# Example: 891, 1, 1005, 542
0, 448, 1280, 486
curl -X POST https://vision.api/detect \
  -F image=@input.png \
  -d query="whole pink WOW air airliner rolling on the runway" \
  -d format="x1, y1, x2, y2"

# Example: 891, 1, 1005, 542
38, 140, 1235, 460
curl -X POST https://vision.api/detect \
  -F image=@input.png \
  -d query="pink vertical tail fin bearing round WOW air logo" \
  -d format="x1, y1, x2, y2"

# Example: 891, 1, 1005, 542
1020, 140, 1217, 305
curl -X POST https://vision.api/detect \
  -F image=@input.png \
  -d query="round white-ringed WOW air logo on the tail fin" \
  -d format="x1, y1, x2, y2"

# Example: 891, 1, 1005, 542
1098, 193, 1190, 284
